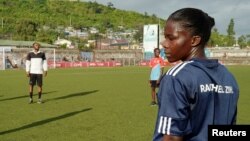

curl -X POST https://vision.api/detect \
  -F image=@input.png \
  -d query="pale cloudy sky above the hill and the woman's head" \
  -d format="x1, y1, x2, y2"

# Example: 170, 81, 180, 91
83, 0, 250, 36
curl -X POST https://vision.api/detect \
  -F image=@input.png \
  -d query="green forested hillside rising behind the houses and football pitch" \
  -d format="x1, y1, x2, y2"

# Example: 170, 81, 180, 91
0, 0, 163, 40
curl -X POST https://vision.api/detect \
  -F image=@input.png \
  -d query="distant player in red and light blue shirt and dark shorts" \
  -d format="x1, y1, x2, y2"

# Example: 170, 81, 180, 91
149, 48, 164, 106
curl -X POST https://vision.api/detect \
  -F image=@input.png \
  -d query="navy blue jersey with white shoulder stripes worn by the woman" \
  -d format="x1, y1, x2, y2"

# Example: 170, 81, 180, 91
153, 59, 239, 141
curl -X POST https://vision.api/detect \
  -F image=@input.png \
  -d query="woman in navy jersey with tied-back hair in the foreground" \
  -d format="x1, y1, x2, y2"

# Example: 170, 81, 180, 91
153, 8, 239, 141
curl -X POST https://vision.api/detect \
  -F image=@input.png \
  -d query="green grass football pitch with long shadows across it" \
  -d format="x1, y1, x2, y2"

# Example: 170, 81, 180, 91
0, 66, 250, 141
